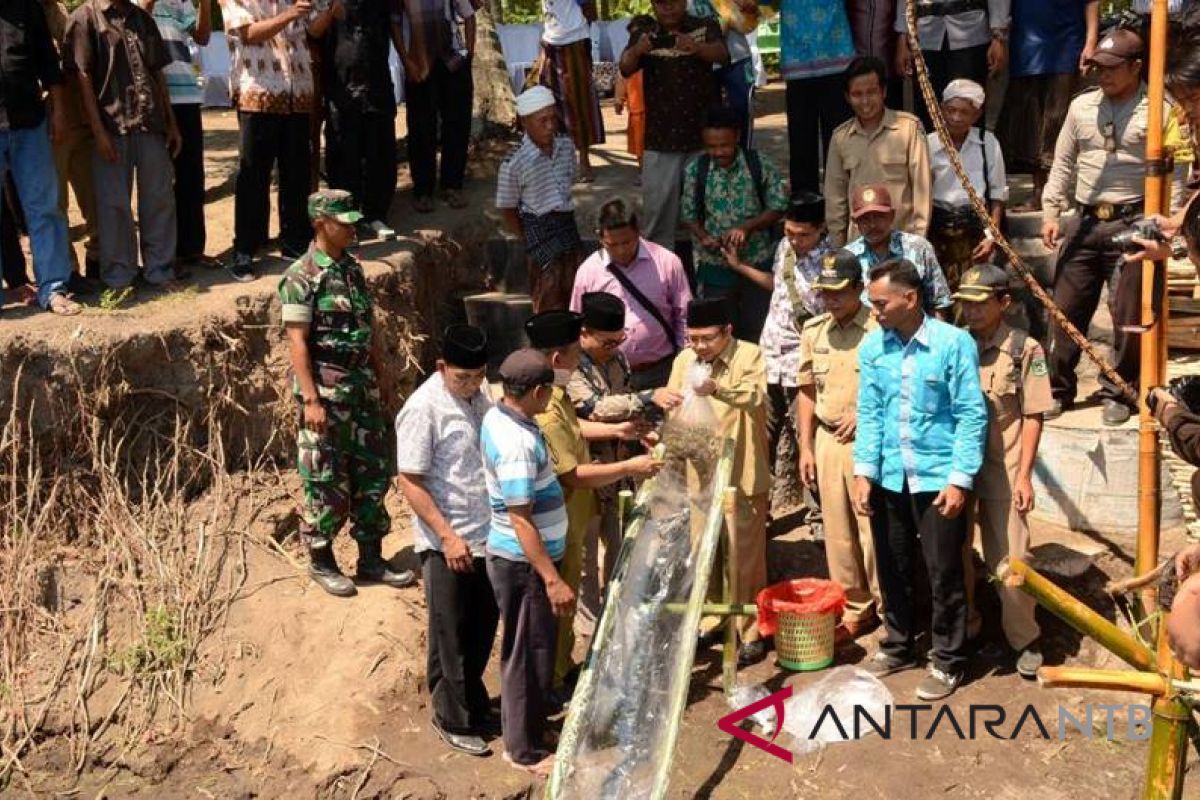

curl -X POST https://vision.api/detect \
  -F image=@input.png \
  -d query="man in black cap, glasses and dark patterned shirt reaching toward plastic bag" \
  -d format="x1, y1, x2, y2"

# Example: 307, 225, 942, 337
566, 291, 682, 633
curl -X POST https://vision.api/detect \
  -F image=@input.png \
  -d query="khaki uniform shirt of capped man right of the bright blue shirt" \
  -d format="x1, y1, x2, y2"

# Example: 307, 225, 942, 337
974, 323, 1054, 499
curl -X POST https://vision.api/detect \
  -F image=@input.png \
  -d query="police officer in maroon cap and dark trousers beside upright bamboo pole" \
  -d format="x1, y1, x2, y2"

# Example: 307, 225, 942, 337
1042, 29, 1174, 425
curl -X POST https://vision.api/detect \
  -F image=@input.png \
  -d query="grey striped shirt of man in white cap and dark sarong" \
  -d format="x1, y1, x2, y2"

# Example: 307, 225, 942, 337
496, 134, 576, 217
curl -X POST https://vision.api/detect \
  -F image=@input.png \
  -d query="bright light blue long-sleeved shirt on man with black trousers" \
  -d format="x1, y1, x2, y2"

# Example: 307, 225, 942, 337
854, 317, 988, 494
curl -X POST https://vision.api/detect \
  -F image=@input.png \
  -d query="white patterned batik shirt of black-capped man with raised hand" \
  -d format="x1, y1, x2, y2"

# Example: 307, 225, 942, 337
758, 237, 832, 387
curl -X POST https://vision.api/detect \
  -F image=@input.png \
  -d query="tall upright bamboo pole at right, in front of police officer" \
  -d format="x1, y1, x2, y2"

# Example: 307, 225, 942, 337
1134, 0, 1169, 613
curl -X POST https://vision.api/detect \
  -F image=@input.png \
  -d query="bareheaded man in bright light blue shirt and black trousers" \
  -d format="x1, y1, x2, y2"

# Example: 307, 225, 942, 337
853, 259, 988, 700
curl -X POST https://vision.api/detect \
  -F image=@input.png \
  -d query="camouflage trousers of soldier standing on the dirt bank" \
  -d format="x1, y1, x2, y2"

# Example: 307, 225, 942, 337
296, 399, 391, 547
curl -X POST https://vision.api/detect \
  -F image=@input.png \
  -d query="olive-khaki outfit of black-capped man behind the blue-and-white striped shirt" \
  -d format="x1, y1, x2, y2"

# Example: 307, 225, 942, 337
536, 386, 596, 686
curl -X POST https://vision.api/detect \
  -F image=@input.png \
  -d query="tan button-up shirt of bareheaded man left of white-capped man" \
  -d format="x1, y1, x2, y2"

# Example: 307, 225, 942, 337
824, 108, 932, 247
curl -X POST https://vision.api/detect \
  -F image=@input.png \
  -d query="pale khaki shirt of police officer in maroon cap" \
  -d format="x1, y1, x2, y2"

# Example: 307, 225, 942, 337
1042, 84, 1178, 222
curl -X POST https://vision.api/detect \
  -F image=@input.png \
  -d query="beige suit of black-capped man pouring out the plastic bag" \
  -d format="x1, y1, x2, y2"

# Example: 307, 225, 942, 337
667, 339, 770, 642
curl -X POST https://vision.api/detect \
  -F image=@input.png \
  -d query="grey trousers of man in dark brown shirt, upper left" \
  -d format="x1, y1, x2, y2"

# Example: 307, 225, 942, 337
91, 133, 175, 289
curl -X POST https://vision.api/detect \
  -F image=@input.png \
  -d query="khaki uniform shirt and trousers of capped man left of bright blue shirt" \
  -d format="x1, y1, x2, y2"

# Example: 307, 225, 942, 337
799, 306, 883, 622
